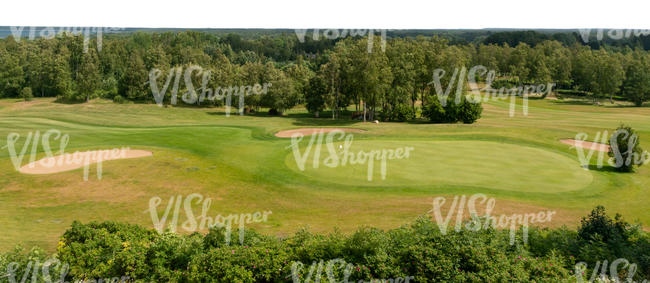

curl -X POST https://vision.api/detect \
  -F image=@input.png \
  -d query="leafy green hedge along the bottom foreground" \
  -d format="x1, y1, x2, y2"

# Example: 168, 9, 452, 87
0, 207, 650, 282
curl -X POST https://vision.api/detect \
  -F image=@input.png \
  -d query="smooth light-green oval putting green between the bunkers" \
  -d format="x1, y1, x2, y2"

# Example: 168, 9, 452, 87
286, 140, 592, 193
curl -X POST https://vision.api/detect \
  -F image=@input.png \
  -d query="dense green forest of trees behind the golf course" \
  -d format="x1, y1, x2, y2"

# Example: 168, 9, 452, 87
0, 30, 650, 122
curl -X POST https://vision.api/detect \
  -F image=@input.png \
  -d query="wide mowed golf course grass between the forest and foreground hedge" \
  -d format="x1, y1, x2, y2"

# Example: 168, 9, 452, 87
0, 99, 650, 251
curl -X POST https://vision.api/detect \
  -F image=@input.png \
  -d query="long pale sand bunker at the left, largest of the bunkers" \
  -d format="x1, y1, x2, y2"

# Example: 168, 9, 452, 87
19, 148, 153, 174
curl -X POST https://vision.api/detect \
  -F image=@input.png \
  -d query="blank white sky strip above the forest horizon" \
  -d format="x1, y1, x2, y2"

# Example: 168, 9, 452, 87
0, 0, 650, 29
